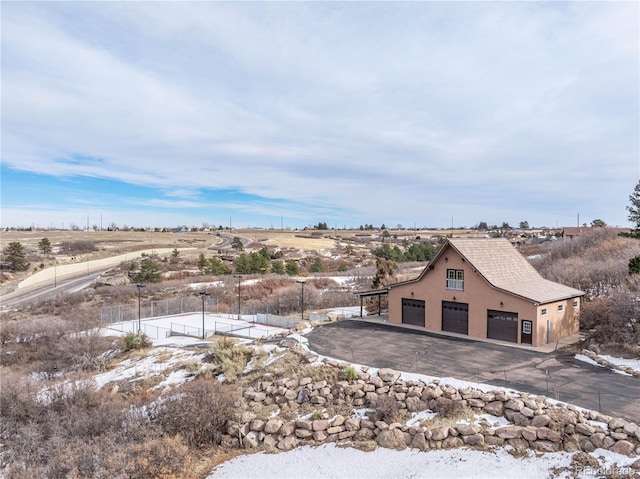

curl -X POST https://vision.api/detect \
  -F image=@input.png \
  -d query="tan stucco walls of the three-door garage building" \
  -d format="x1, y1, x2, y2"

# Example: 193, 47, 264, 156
389, 246, 579, 346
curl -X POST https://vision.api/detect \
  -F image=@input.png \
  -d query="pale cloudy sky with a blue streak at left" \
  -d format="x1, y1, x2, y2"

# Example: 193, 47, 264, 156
0, 2, 640, 228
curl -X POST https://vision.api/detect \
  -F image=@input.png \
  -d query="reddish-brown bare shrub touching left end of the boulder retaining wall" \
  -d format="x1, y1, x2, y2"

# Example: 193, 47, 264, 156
156, 379, 237, 448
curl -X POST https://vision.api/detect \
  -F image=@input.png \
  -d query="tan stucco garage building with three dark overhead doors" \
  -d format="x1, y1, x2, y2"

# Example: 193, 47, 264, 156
388, 238, 585, 346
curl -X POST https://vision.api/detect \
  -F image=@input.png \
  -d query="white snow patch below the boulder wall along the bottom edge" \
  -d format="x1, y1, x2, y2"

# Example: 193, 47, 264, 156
207, 444, 633, 479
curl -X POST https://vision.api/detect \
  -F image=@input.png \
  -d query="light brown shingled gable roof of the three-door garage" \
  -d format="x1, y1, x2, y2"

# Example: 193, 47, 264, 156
390, 238, 585, 304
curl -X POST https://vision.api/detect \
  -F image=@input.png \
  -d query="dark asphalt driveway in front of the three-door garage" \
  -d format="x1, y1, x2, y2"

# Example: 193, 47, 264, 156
308, 320, 640, 423
